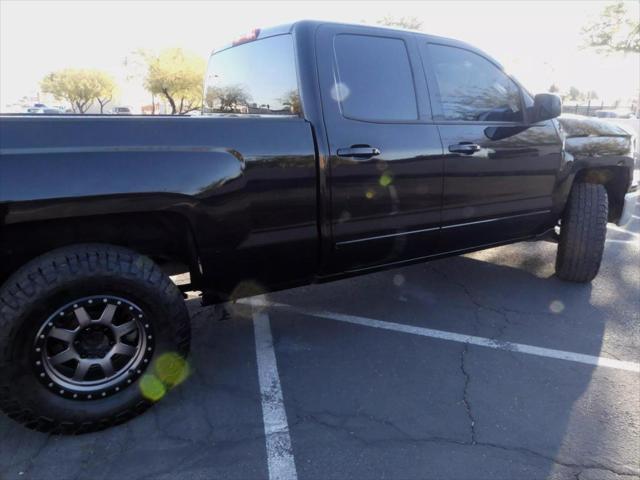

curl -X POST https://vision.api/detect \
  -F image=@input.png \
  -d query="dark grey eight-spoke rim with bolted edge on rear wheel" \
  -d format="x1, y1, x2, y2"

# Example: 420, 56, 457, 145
31, 295, 154, 401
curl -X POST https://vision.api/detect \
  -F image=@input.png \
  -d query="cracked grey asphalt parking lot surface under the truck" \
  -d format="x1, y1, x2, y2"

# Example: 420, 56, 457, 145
0, 203, 640, 480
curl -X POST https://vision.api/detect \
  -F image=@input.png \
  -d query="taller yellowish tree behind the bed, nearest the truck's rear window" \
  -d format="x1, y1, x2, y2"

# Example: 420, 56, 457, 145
134, 48, 205, 115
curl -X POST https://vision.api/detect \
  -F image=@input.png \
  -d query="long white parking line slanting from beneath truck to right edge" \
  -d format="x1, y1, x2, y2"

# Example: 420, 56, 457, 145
270, 303, 640, 373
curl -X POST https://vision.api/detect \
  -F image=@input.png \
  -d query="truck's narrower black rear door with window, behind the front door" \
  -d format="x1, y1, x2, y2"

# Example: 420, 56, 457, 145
316, 25, 443, 273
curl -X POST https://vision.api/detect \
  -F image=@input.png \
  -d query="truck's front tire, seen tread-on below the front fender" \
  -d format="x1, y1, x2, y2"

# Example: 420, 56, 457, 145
556, 183, 608, 283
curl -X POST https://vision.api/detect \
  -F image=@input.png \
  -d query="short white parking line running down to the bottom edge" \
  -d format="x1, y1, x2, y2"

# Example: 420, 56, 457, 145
253, 310, 298, 480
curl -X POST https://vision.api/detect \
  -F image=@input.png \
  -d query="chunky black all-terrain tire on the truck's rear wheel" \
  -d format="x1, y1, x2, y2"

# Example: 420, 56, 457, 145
0, 244, 190, 434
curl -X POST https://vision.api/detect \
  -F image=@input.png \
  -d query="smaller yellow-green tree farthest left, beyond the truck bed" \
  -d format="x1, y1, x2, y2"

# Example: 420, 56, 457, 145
40, 68, 109, 114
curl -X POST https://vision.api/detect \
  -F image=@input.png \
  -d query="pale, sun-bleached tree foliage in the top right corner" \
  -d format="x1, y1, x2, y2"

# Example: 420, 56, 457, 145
582, 1, 640, 54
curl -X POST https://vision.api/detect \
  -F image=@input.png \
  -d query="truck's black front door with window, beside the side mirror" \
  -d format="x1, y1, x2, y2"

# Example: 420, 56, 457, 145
420, 39, 562, 251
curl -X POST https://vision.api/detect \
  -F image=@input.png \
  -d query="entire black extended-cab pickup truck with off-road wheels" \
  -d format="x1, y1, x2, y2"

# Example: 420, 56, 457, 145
0, 21, 637, 433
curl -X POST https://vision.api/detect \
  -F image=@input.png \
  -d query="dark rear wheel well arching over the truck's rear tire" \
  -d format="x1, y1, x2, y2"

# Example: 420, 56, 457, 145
0, 212, 199, 283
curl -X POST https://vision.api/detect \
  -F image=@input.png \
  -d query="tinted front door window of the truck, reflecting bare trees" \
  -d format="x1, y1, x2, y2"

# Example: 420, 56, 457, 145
425, 45, 522, 122
